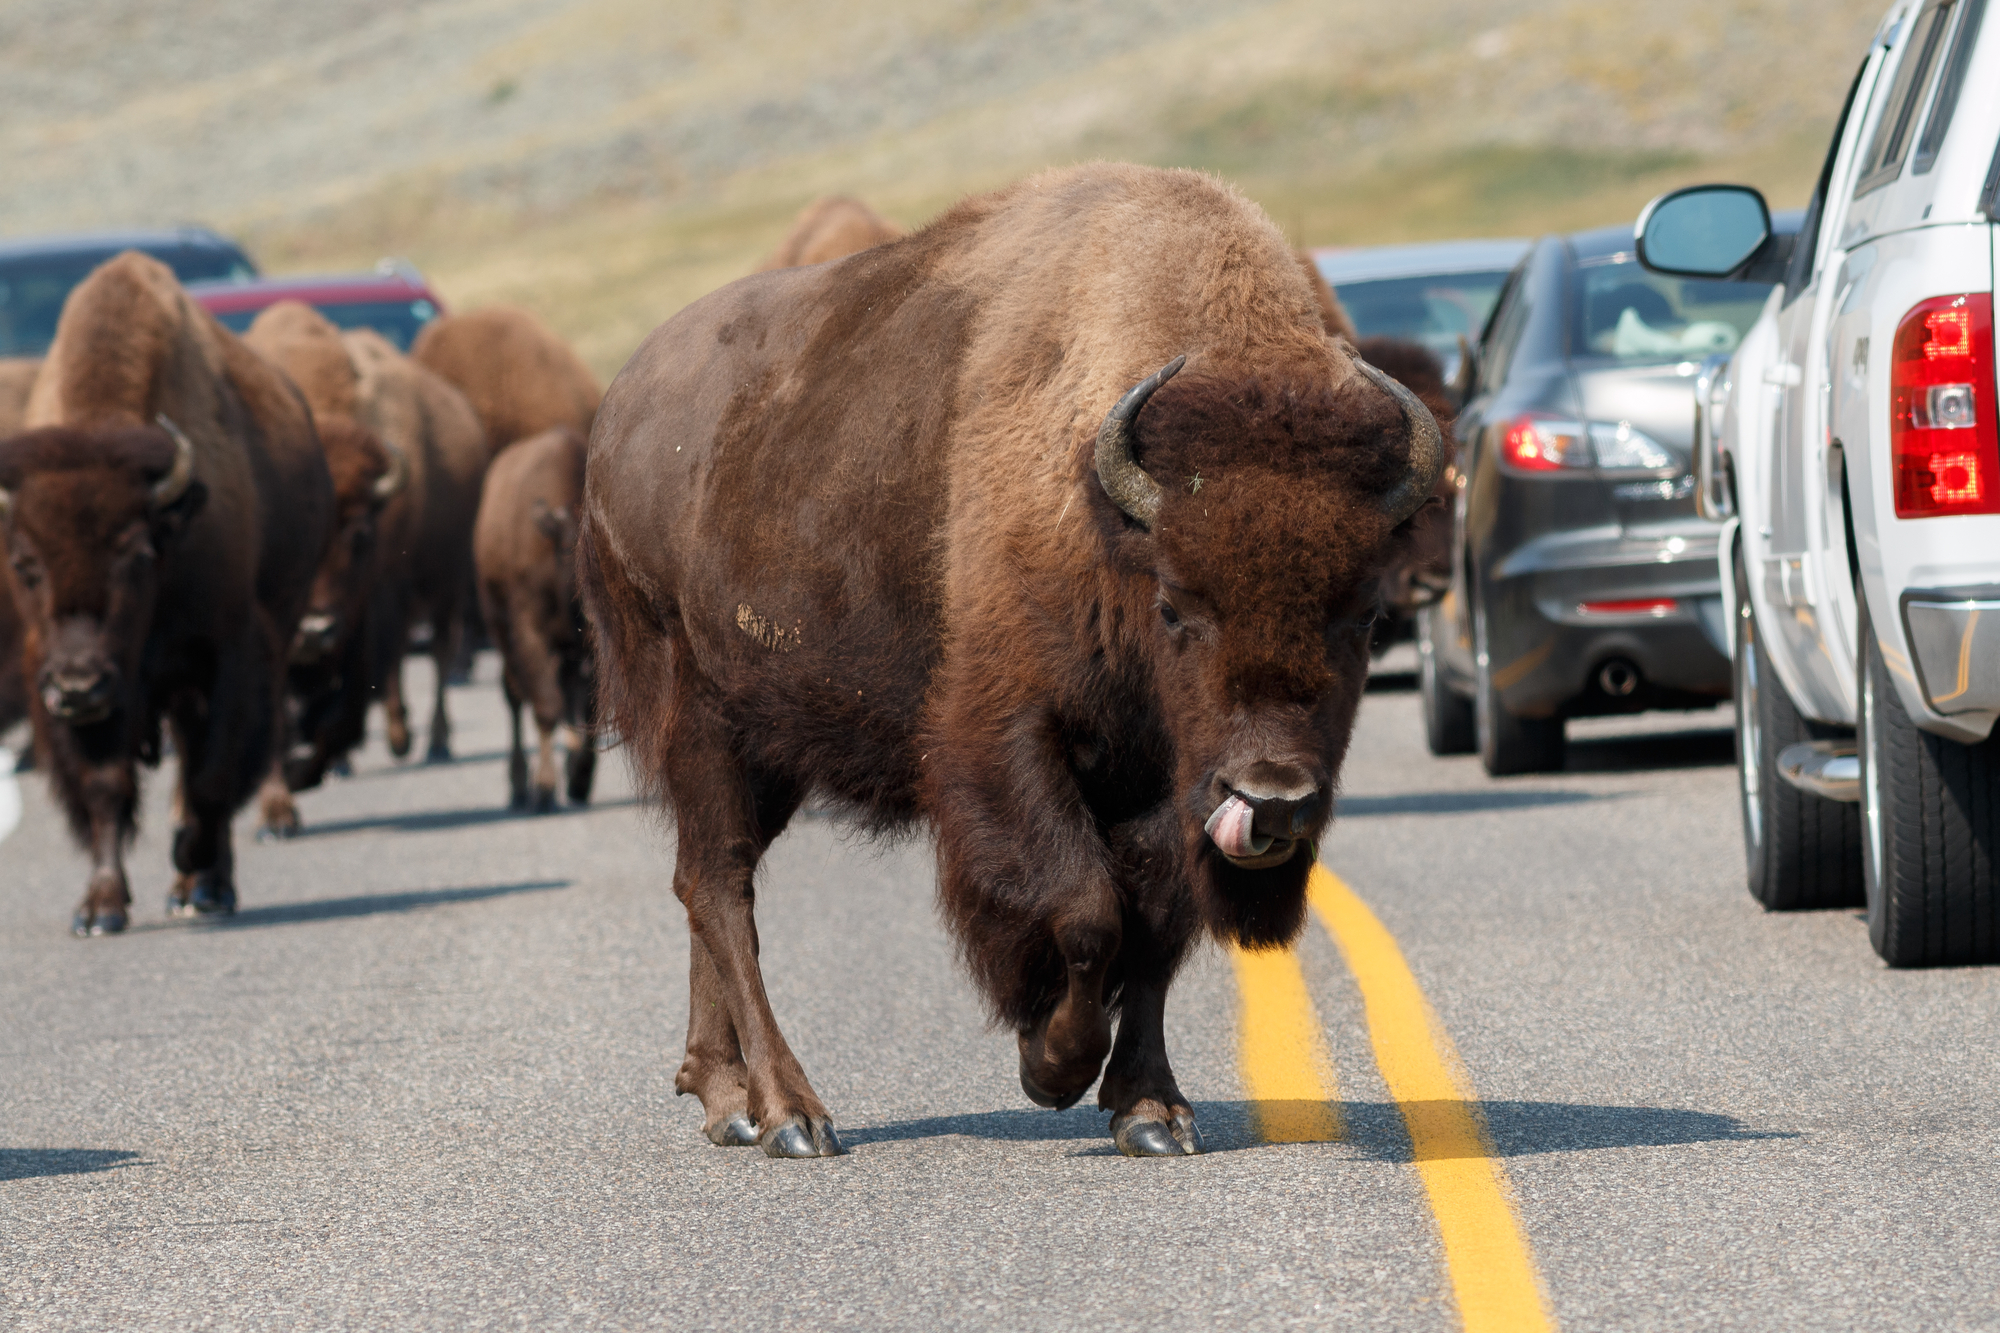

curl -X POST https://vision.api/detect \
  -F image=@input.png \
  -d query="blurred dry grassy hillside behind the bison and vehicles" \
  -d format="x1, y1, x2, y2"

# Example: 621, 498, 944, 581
0, 0, 1882, 374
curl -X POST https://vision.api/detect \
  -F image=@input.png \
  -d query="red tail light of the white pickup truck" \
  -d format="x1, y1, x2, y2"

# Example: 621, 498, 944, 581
1888, 292, 2000, 518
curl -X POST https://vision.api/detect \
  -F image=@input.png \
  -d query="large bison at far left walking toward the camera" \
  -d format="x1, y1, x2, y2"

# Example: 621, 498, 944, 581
0, 252, 332, 935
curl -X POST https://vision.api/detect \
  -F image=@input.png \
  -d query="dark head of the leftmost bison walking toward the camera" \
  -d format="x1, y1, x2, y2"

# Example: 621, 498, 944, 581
0, 416, 208, 727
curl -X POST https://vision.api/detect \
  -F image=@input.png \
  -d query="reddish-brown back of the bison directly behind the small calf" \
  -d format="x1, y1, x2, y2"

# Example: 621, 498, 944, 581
410, 306, 604, 452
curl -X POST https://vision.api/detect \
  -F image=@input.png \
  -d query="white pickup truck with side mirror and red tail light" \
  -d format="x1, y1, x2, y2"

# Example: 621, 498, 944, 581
1636, 0, 2000, 967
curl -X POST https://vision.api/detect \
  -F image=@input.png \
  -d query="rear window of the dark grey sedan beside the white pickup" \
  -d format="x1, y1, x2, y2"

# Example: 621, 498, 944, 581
1570, 254, 1770, 364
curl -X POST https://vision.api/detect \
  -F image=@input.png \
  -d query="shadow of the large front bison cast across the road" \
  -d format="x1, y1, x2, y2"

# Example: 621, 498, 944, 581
840, 1101, 1798, 1163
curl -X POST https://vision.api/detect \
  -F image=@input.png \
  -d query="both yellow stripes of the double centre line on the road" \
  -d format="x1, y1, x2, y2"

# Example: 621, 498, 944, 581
1232, 867, 1554, 1333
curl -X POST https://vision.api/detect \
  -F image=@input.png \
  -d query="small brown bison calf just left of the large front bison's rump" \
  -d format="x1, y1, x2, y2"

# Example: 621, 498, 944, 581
472, 426, 598, 813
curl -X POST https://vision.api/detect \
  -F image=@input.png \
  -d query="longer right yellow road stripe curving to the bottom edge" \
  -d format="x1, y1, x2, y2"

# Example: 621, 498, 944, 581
1308, 867, 1554, 1333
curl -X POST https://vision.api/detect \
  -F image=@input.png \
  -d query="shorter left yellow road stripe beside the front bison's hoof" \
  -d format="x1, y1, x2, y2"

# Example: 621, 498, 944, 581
1230, 932, 1346, 1143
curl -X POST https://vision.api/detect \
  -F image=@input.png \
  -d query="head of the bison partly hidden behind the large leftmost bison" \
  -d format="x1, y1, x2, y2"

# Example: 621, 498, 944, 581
292, 416, 410, 667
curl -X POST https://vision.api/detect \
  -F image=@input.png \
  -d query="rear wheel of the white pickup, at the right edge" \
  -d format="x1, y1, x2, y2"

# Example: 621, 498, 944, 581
1860, 606, 2000, 967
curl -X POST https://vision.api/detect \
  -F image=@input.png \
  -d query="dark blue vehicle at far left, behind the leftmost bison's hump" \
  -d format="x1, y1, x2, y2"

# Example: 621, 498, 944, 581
0, 226, 256, 356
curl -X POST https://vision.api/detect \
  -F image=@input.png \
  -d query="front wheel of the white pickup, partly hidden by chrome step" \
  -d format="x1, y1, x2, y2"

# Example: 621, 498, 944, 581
1734, 552, 1862, 913
